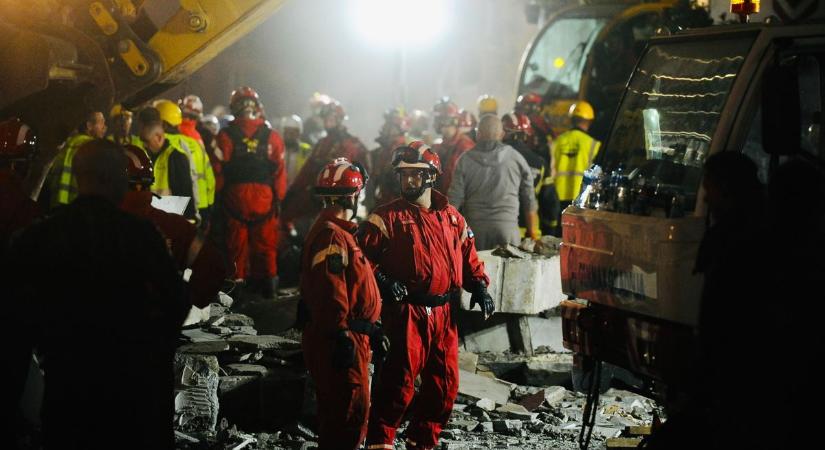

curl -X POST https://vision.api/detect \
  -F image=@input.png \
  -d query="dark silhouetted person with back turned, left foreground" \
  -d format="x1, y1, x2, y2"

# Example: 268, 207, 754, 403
6, 139, 189, 449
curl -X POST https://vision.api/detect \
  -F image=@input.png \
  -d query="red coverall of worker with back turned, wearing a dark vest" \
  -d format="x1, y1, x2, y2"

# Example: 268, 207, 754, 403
215, 118, 286, 280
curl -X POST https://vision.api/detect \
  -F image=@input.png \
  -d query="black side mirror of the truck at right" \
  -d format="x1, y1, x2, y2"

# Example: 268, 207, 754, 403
762, 57, 802, 155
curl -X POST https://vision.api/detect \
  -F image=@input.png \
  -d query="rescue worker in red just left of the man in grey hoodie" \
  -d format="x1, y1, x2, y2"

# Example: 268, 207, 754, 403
433, 97, 476, 192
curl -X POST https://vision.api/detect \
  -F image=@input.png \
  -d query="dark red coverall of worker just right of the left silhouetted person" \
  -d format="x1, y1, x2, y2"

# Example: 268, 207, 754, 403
120, 191, 226, 308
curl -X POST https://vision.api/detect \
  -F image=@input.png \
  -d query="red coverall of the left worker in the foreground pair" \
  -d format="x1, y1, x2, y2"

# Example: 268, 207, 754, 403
301, 210, 381, 449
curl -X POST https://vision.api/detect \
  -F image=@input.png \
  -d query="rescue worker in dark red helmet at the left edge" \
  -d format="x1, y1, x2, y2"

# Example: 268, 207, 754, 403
0, 118, 40, 251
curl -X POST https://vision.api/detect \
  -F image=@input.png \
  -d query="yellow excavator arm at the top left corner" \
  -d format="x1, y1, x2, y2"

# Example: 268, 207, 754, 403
0, 0, 284, 192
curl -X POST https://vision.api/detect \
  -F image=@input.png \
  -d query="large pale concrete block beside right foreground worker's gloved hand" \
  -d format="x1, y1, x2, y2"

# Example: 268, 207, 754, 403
461, 250, 567, 314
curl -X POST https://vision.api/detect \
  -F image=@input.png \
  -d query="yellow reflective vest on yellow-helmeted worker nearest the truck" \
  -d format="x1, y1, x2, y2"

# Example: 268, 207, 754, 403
551, 128, 601, 202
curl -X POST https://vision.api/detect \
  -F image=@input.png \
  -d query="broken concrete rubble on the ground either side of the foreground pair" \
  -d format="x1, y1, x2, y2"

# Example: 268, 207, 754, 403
175, 286, 656, 450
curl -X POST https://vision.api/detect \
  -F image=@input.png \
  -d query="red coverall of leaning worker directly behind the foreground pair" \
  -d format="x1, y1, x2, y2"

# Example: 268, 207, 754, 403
282, 130, 366, 229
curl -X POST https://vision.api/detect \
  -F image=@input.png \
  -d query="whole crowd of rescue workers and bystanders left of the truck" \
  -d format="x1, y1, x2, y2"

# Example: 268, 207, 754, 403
0, 87, 598, 449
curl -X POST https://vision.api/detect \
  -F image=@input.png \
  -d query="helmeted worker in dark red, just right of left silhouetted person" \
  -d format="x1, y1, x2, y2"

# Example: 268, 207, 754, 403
120, 145, 227, 308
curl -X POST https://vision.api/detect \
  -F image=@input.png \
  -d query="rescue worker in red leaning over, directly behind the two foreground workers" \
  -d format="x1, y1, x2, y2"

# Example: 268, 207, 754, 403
283, 101, 367, 235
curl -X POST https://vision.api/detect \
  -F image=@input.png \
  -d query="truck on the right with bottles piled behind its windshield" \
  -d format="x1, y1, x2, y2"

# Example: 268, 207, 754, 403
561, 1, 825, 405
